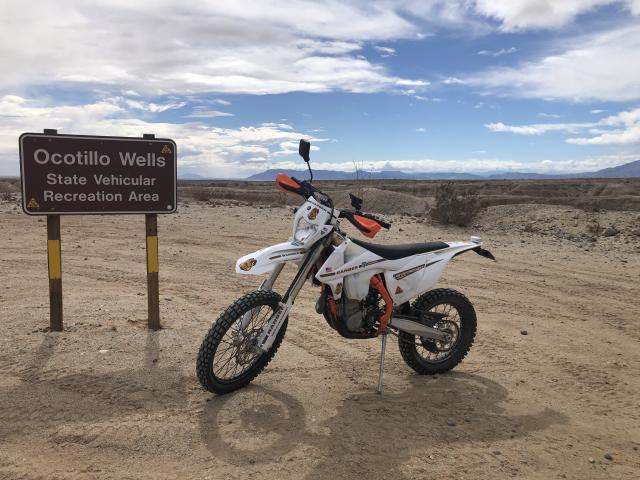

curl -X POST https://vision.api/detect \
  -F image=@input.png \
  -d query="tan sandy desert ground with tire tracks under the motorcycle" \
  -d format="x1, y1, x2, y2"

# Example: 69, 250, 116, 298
0, 198, 640, 479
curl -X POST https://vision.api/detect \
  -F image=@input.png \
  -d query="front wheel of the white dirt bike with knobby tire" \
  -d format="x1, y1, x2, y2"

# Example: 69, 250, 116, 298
196, 290, 288, 394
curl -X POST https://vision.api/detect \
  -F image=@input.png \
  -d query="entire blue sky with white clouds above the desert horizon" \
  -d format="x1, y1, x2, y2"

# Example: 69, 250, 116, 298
0, 0, 640, 178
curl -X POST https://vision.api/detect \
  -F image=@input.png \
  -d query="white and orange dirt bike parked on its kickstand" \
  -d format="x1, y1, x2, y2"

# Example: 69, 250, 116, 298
196, 140, 495, 394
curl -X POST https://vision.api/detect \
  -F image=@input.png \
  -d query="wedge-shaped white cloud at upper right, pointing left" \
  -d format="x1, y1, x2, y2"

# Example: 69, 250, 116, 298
464, 23, 640, 101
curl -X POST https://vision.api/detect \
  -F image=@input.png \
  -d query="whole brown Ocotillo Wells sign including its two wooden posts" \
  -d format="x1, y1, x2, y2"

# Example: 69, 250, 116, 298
20, 129, 177, 332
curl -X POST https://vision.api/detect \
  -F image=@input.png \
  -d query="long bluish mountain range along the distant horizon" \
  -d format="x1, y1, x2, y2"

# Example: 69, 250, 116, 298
246, 160, 640, 181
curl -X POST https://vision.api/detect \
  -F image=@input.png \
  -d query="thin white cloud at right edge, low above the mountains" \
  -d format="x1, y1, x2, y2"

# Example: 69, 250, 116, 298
485, 108, 640, 145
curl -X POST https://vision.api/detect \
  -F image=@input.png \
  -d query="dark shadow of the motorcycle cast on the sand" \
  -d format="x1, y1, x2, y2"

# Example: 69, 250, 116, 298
201, 372, 567, 479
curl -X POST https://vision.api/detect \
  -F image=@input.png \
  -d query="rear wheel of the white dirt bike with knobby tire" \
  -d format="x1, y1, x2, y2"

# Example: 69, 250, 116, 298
398, 288, 477, 375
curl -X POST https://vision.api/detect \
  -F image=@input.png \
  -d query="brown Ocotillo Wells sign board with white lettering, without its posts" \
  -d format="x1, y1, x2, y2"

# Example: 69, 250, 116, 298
20, 133, 177, 215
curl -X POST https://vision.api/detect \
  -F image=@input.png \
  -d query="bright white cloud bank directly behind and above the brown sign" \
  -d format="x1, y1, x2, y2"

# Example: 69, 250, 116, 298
0, 95, 318, 177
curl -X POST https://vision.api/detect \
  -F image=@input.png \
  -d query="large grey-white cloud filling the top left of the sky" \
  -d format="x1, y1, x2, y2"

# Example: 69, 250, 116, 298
0, 0, 424, 96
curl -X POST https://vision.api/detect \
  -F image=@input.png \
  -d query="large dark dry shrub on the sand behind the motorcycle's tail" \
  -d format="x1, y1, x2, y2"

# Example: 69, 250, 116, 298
429, 182, 480, 227
